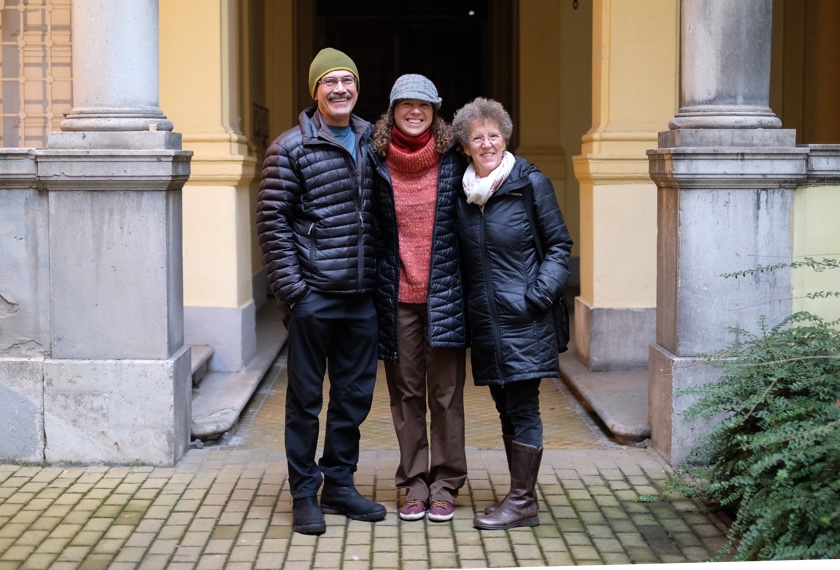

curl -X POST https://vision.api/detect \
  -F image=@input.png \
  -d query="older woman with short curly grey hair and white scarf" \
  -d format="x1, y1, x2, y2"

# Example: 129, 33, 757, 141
452, 98, 572, 529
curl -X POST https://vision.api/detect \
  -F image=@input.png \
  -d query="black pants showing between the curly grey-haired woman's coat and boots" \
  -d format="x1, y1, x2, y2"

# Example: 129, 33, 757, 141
490, 378, 542, 448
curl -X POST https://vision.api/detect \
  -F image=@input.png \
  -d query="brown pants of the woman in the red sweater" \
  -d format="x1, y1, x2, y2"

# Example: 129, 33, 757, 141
385, 303, 467, 504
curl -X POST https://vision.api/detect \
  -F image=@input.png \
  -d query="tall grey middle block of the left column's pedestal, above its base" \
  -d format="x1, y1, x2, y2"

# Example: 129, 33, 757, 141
50, 191, 183, 360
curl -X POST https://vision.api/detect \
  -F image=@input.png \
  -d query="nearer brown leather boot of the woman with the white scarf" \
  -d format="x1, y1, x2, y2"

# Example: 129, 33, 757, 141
473, 441, 542, 530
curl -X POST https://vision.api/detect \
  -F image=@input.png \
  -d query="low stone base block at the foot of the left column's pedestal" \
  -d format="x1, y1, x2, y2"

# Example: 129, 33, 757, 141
44, 346, 192, 465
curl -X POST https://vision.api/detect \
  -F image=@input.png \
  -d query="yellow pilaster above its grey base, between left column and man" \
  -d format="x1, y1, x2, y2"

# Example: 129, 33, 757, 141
160, 0, 256, 308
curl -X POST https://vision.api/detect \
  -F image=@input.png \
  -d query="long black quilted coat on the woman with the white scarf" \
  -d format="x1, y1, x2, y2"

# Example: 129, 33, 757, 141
458, 157, 572, 385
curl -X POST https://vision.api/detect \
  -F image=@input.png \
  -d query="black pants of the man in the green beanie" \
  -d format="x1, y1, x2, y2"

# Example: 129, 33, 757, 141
286, 291, 378, 499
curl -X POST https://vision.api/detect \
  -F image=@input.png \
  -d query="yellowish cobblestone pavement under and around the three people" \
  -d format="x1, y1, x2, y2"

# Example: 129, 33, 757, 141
0, 348, 725, 570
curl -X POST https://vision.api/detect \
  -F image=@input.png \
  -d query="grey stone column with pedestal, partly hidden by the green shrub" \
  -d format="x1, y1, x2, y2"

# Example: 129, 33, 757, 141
648, 0, 807, 465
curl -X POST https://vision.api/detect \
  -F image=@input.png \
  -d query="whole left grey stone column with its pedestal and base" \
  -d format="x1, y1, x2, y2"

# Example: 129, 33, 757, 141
36, 0, 191, 465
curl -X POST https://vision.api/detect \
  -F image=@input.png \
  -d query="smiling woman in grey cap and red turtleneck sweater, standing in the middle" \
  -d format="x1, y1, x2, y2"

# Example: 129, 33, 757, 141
373, 74, 467, 522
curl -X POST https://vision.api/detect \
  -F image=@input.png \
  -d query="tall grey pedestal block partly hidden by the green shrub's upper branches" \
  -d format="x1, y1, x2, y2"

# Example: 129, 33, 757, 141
656, 188, 794, 356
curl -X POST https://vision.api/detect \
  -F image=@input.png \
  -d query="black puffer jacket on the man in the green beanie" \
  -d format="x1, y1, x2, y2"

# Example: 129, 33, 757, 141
257, 107, 375, 304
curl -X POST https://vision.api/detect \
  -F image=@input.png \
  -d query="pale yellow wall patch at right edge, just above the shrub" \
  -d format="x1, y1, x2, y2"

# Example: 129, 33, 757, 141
793, 185, 840, 320
